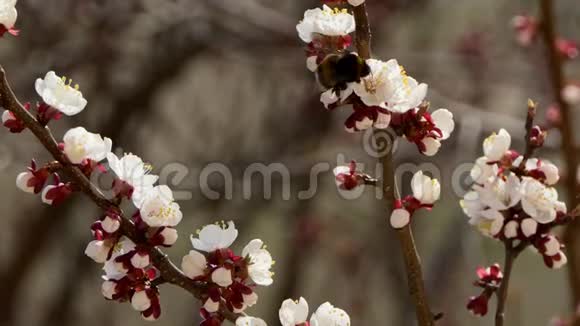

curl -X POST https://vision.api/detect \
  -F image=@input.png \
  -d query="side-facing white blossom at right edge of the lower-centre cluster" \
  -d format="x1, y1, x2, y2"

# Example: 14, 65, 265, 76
242, 239, 274, 286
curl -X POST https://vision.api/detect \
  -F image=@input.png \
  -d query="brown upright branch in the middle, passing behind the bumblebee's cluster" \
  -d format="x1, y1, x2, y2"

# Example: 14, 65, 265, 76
353, 3, 435, 326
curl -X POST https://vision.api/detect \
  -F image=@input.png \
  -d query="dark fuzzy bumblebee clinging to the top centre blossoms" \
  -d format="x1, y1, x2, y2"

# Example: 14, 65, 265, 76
316, 52, 371, 90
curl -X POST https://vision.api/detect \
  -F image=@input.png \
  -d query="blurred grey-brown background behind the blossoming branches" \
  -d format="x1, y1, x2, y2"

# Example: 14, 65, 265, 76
0, 0, 580, 326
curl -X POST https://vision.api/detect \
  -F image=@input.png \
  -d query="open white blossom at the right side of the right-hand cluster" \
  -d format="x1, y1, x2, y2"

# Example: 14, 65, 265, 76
521, 177, 563, 224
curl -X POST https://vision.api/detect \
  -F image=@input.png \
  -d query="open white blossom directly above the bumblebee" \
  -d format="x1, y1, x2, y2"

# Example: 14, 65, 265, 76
296, 5, 356, 43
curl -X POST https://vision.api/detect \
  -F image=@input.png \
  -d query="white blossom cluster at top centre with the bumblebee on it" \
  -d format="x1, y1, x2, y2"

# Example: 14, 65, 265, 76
296, 1, 454, 156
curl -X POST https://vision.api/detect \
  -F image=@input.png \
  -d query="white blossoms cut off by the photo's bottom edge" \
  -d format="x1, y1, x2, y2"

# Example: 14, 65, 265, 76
236, 297, 350, 326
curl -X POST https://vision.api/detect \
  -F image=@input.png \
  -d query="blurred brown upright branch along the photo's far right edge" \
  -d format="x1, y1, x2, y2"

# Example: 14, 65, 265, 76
540, 0, 580, 314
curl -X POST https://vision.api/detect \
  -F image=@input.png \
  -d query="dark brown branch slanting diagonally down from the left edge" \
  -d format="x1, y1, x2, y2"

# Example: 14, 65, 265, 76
0, 66, 238, 321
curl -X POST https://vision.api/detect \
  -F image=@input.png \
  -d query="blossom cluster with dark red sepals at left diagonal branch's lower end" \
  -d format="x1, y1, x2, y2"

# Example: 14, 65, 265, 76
181, 221, 274, 326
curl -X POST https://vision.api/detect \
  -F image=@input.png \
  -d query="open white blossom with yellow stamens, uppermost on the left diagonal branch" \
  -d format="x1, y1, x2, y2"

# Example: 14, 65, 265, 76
35, 71, 87, 116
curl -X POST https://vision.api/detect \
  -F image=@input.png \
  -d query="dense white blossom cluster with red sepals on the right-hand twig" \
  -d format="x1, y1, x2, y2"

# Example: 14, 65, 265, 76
461, 127, 568, 268
